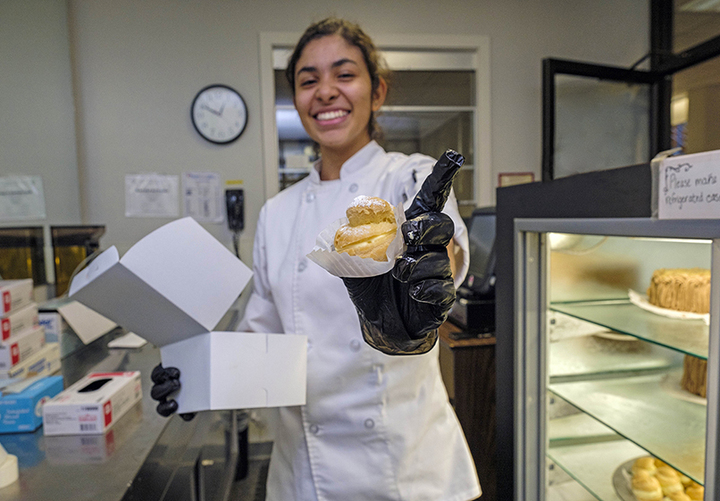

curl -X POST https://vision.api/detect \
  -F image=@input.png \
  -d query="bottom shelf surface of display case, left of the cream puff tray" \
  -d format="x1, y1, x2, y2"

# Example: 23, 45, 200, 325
547, 439, 647, 501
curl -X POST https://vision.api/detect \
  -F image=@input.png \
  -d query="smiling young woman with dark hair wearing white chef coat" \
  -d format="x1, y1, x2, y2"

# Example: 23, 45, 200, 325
153, 19, 480, 501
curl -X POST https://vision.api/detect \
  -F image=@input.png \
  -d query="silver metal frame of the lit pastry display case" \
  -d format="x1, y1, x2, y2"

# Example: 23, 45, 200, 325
514, 218, 720, 500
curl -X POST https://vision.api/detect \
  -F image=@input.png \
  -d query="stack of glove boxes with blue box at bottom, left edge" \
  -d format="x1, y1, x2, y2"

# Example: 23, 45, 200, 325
0, 279, 63, 433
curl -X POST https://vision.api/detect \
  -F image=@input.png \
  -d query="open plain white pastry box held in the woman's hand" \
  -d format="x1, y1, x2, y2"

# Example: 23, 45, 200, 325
69, 217, 307, 413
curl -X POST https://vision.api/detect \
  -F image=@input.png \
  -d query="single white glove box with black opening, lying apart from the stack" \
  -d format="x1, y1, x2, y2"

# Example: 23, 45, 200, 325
43, 371, 142, 435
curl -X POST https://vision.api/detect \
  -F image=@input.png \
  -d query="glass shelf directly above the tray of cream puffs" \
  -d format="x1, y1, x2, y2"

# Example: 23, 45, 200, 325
548, 372, 707, 484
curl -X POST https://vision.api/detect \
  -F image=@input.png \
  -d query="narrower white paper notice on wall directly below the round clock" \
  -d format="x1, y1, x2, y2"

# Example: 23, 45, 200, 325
182, 172, 225, 223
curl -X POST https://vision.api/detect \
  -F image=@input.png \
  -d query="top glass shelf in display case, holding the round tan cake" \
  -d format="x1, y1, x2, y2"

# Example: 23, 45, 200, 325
550, 299, 709, 360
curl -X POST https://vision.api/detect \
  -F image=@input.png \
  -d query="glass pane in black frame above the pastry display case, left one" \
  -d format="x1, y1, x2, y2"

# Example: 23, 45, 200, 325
553, 75, 649, 179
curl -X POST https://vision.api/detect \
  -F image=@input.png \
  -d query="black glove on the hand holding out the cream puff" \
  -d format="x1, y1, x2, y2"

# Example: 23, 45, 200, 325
342, 150, 465, 355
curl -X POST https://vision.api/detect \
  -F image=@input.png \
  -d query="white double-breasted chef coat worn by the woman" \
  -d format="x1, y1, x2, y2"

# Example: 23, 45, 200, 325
239, 141, 480, 501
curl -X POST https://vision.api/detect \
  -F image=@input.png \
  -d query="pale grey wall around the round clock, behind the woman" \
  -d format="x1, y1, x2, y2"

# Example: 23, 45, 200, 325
0, 0, 649, 270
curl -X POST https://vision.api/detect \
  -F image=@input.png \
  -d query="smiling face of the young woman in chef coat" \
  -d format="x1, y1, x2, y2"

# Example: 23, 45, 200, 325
294, 35, 386, 154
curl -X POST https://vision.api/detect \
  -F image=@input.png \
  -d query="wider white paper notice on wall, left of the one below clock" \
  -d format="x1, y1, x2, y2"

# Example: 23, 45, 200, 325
125, 174, 180, 217
